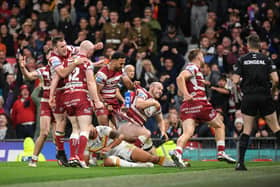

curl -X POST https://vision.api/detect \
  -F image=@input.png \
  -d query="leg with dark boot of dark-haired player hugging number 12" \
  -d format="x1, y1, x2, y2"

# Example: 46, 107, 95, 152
54, 114, 69, 167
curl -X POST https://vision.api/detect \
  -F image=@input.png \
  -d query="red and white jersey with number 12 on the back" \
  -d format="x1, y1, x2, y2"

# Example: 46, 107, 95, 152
64, 54, 93, 92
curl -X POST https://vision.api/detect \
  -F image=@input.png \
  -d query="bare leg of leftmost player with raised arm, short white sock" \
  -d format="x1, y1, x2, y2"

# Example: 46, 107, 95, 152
28, 116, 51, 167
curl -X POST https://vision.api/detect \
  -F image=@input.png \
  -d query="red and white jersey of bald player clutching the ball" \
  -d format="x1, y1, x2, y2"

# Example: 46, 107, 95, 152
127, 87, 161, 125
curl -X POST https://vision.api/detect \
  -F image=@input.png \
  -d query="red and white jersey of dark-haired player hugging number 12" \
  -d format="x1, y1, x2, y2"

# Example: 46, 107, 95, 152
48, 45, 79, 88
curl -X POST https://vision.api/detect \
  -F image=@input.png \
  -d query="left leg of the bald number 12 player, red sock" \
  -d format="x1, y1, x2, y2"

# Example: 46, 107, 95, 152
68, 116, 80, 167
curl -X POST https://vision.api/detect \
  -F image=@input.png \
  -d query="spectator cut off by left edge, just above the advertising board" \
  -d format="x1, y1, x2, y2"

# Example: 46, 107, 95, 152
0, 113, 16, 140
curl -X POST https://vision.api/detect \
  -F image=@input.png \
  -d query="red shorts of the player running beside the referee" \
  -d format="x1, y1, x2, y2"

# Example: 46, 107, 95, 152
180, 101, 217, 122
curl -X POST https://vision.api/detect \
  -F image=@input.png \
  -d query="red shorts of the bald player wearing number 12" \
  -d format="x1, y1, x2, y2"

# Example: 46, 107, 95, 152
63, 91, 93, 116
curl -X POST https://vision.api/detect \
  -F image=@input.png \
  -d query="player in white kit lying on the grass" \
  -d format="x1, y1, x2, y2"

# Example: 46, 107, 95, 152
85, 126, 175, 167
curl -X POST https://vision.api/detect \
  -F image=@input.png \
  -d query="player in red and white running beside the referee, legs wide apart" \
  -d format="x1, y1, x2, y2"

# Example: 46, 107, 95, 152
169, 49, 235, 167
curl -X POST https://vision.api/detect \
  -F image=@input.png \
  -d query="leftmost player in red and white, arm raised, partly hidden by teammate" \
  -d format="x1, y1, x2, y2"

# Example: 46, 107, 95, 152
19, 49, 54, 167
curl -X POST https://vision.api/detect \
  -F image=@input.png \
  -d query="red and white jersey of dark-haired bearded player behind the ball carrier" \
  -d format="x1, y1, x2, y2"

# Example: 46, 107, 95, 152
96, 65, 123, 101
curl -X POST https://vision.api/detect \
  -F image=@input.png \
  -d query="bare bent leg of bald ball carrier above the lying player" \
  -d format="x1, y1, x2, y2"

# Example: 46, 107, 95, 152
118, 122, 153, 148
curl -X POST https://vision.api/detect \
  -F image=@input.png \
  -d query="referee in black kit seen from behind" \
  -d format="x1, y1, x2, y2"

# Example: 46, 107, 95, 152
233, 34, 280, 170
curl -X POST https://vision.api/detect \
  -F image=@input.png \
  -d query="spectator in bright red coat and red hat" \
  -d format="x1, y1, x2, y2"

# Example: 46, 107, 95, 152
11, 85, 36, 139
